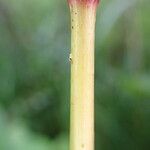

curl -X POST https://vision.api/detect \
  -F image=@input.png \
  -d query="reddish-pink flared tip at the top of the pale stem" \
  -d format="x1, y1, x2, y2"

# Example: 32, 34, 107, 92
68, 0, 100, 5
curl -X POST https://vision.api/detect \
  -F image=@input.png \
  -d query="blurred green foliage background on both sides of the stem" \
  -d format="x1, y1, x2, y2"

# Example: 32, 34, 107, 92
0, 0, 150, 150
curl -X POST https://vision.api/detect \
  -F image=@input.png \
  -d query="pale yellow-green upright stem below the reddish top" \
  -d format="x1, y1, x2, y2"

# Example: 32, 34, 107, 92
70, 0, 97, 150
